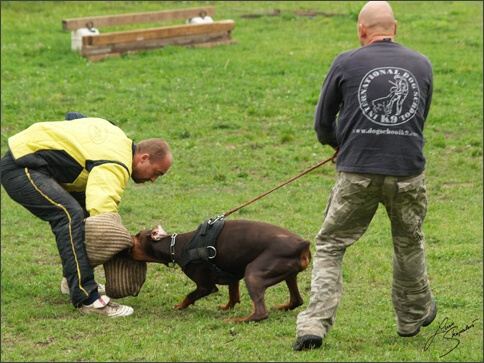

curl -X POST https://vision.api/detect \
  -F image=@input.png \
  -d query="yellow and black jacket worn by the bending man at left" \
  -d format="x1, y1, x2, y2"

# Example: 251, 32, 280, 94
8, 118, 135, 216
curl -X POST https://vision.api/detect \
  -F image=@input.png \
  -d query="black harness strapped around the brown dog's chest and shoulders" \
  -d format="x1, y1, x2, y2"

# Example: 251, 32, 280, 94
172, 218, 240, 280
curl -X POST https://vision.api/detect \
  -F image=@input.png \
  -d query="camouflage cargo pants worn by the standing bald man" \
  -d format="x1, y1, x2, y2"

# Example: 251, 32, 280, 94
296, 172, 433, 338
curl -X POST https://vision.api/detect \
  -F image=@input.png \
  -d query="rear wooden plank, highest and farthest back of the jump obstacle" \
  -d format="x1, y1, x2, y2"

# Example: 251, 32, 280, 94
62, 6, 215, 30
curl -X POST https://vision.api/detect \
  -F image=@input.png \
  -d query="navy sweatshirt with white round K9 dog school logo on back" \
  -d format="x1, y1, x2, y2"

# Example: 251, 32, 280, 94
314, 41, 433, 176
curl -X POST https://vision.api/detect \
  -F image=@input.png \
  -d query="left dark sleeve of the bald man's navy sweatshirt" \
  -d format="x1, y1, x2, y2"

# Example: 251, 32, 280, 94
314, 62, 342, 148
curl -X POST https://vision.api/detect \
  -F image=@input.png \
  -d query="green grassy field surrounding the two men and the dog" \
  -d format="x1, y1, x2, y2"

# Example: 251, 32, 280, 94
1, 1, 483, 362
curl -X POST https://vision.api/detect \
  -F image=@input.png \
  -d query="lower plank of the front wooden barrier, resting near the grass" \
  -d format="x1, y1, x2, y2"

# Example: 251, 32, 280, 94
82, 31, 237, 61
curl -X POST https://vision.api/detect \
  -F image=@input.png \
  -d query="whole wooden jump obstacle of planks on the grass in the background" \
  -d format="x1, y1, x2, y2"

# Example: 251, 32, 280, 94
62, 6, 236, 61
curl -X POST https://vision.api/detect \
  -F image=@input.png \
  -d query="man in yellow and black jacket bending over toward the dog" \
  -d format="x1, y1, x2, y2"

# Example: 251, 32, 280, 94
1, 113, 172, 317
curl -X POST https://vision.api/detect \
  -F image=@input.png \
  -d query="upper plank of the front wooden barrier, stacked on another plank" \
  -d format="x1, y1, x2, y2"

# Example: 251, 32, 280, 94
82, 20, 235, 46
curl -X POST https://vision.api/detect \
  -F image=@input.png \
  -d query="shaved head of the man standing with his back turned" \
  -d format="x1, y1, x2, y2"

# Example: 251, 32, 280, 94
358, 1, 397, 45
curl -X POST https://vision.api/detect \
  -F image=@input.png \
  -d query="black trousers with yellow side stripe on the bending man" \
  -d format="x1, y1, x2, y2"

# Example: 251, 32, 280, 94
0, 151, 97, 307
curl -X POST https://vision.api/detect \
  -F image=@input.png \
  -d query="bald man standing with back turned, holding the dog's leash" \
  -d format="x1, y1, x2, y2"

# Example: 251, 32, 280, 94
293, 1, 437, 350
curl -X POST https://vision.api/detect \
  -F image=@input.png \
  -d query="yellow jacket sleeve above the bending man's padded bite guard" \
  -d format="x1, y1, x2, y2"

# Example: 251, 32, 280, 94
86, 163, 129, 217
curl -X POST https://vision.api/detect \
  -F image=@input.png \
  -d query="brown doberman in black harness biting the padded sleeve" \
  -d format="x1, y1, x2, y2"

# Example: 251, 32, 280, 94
130, 220, 311, 322
